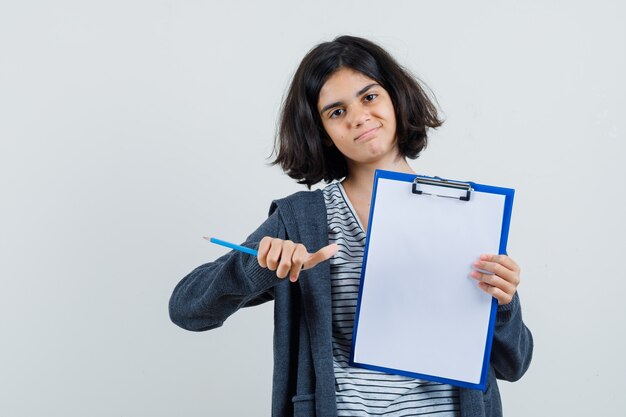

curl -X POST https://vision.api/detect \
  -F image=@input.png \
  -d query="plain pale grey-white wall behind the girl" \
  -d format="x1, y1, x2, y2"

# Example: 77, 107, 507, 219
0, 0, 626, 417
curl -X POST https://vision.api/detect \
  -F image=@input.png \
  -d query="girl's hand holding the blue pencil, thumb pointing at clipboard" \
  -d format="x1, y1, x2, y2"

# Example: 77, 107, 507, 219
257, 236, 339, 282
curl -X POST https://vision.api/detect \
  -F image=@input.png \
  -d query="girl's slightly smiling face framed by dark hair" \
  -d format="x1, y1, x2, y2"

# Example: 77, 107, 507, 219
317, 68, 399, 169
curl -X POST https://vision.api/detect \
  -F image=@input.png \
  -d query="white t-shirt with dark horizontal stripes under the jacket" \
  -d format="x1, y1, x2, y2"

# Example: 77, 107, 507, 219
324, 183, 460, 417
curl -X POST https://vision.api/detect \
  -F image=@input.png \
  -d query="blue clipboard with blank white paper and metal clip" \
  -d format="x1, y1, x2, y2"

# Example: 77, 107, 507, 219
350, 170, 515, 391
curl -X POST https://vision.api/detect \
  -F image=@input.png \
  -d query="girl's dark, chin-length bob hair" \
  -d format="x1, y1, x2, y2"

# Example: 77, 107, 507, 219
272, 36, 443, 188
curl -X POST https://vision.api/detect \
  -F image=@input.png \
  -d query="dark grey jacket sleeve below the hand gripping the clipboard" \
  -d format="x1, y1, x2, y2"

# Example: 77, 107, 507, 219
491, 293, 533, 381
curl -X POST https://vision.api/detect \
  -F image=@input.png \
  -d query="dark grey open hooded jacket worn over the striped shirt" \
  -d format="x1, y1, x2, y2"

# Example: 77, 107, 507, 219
169, 190, 533, 417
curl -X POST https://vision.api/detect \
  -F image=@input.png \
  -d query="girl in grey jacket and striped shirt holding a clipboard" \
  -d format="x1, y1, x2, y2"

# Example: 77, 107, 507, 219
170, 36, 532, 417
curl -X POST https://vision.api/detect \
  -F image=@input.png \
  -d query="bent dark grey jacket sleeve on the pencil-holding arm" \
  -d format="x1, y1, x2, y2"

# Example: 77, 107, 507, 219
169, 206, 285, 331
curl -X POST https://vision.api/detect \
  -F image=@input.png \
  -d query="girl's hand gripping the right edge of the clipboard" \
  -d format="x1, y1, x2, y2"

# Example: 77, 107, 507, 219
470, 254, 520, 305
